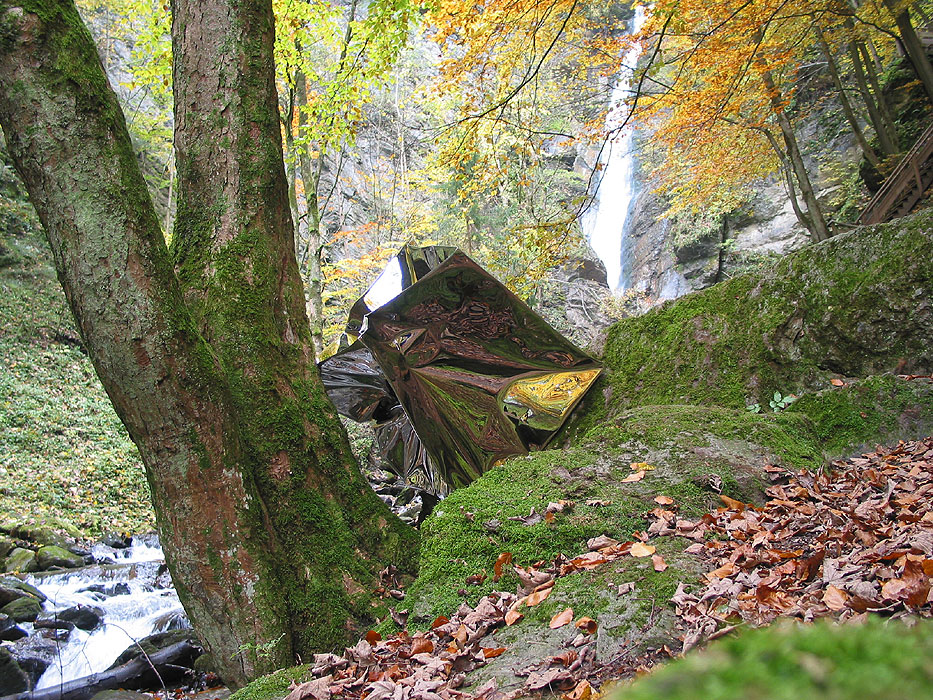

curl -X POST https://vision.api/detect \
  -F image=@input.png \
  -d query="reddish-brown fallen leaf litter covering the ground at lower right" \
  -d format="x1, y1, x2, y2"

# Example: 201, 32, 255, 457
286, 438, 933, 700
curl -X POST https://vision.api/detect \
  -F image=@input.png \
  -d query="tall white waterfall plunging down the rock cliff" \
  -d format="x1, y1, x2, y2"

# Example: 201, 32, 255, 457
581, 6, 645, 291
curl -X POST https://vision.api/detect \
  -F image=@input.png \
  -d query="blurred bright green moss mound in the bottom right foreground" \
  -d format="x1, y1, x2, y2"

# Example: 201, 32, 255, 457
612, 618, 933, 700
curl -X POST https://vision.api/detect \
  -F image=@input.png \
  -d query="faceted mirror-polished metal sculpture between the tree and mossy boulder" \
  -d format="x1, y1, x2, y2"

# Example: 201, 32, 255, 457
320, 246, 601, 496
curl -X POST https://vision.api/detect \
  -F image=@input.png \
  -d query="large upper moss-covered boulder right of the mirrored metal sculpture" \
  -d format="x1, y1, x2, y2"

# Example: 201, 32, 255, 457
590, 211, 933, 420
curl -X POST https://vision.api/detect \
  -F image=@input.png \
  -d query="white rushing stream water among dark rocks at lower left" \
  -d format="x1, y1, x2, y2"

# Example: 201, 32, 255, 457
28, 544, 184, 690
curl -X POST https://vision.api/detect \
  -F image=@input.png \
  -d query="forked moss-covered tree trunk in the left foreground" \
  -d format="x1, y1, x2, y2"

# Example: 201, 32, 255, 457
0, 0, 416, 686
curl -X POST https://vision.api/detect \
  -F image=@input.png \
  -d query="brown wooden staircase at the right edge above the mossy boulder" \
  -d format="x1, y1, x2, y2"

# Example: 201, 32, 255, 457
859, 123, 933, 224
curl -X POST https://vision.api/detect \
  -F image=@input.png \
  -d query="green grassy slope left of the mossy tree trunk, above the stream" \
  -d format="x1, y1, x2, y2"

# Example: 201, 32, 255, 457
0, 224, 154, 536
